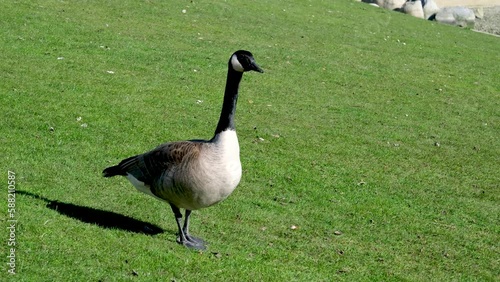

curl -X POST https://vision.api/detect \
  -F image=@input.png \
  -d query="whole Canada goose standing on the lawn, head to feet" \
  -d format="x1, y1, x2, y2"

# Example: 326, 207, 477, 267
103, 50, 264, 249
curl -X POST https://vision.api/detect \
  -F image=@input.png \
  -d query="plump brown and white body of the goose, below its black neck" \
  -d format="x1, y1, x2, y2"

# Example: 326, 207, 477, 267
121, 130, 241, 210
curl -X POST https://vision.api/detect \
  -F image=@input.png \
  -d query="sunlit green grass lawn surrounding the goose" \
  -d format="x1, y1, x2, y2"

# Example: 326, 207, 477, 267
0, 0, 500, 281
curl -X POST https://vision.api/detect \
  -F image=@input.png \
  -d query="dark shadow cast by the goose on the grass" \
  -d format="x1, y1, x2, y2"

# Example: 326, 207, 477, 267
16, 190, 165, 236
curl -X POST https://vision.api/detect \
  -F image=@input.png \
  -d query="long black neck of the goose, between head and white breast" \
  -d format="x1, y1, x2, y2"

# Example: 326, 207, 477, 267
215, 66, 243, 135
